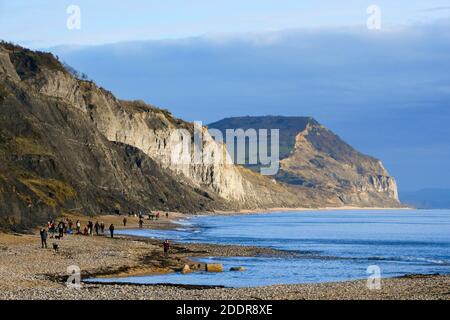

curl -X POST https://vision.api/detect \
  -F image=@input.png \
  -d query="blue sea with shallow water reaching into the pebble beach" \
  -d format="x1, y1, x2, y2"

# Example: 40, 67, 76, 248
87, 210, 450, 287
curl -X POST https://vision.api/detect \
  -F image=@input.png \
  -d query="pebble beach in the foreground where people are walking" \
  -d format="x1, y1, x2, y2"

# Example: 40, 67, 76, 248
0, 213, 450, 300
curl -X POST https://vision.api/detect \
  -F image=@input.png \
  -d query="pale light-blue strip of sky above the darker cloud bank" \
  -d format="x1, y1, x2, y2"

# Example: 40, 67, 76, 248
0, 0, 450, 48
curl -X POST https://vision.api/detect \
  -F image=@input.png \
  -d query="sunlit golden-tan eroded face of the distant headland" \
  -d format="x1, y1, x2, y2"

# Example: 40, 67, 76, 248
280, 124, 398, 206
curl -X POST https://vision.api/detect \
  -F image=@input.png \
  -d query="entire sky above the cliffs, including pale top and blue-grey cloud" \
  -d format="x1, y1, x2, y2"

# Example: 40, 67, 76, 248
0, 0, 450, 191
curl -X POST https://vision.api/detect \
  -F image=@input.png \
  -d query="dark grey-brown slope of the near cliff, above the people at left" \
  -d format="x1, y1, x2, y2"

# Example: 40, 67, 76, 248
0, 46, 232, 229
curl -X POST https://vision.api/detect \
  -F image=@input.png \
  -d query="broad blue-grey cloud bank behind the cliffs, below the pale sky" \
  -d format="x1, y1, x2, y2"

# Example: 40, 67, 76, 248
53, 20, 450, 189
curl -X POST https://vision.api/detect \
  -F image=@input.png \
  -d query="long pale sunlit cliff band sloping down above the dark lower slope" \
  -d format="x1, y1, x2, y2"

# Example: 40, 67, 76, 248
19, 64, 245, 201
